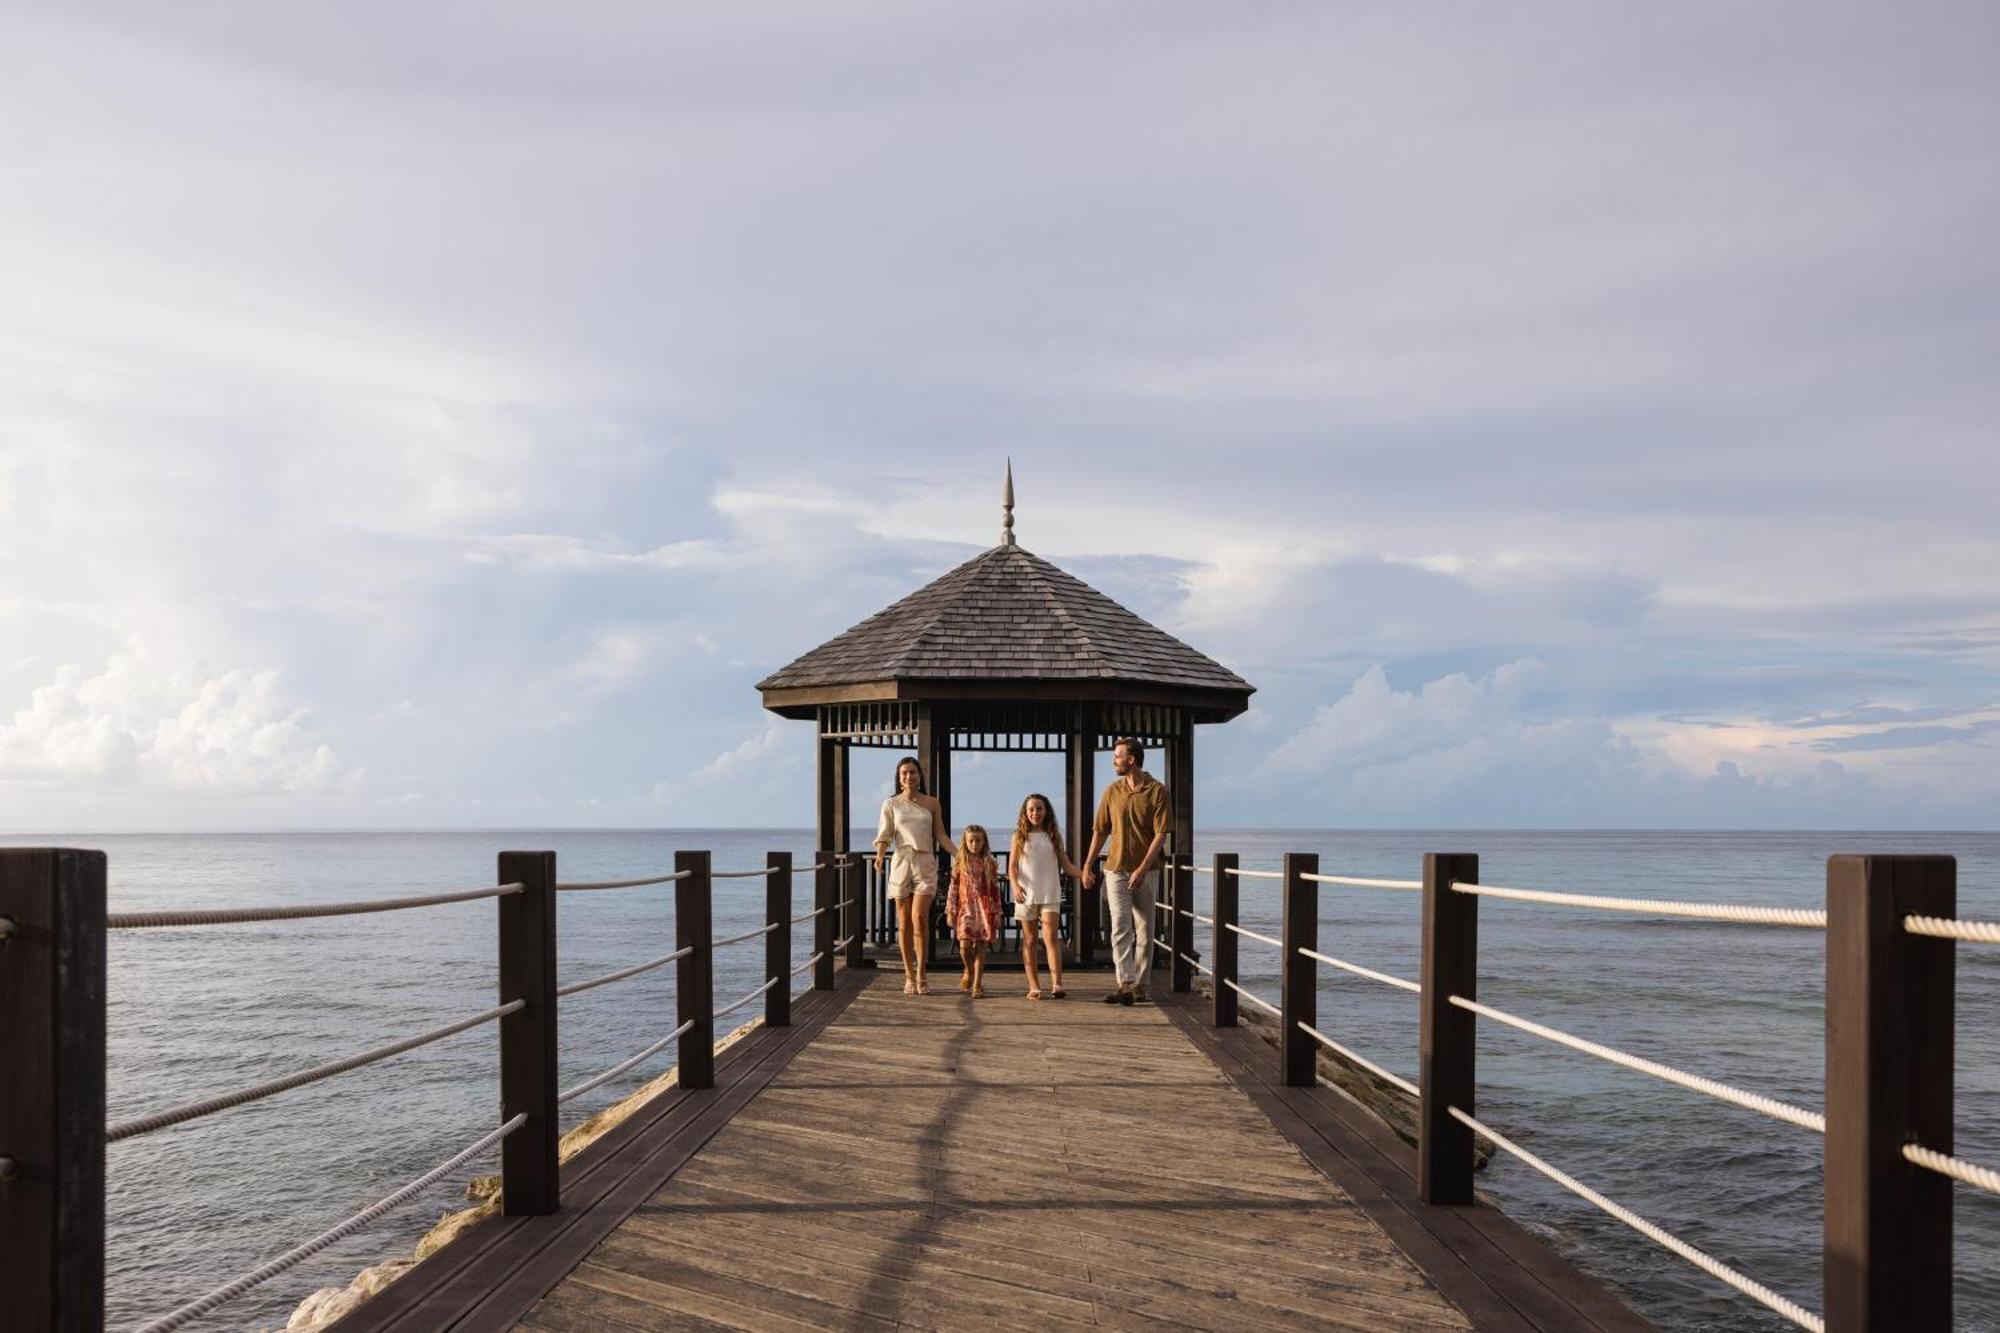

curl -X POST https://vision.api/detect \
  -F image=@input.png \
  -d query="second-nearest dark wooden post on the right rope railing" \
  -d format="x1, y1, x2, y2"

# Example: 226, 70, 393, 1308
1416, 853, 1480, 1203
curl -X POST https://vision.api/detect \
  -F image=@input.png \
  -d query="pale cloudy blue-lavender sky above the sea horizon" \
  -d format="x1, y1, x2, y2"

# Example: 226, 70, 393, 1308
0, 0, 2000, 833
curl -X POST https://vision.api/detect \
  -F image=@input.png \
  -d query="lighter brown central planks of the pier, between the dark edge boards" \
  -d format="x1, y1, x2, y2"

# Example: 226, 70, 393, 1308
518, 964, 1560, 1333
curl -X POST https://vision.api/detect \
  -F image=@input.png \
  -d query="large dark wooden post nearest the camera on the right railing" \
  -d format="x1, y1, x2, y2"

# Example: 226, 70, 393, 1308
1822, 857, 1958, 1333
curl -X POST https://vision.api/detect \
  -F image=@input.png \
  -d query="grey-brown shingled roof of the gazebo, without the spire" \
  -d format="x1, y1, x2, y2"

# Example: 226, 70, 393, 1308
758, 542, 1256, 713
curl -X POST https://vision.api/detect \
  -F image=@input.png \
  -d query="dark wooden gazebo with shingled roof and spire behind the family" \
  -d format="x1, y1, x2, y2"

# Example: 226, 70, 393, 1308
758, 464, 1256, 959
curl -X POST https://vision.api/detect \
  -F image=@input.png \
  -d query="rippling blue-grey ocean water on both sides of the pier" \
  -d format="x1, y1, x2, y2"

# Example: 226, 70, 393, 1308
0, 819, 2000, 1331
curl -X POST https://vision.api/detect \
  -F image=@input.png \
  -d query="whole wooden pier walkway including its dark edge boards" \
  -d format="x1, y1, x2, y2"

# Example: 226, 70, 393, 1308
342, 973, 1650, 1333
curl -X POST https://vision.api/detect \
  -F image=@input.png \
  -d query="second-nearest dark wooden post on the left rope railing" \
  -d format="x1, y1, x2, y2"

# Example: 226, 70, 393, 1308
498, 851, 562, 1217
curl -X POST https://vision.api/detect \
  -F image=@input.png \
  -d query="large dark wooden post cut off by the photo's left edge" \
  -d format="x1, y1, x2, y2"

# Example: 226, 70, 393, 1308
0, 847, 106, 1333
